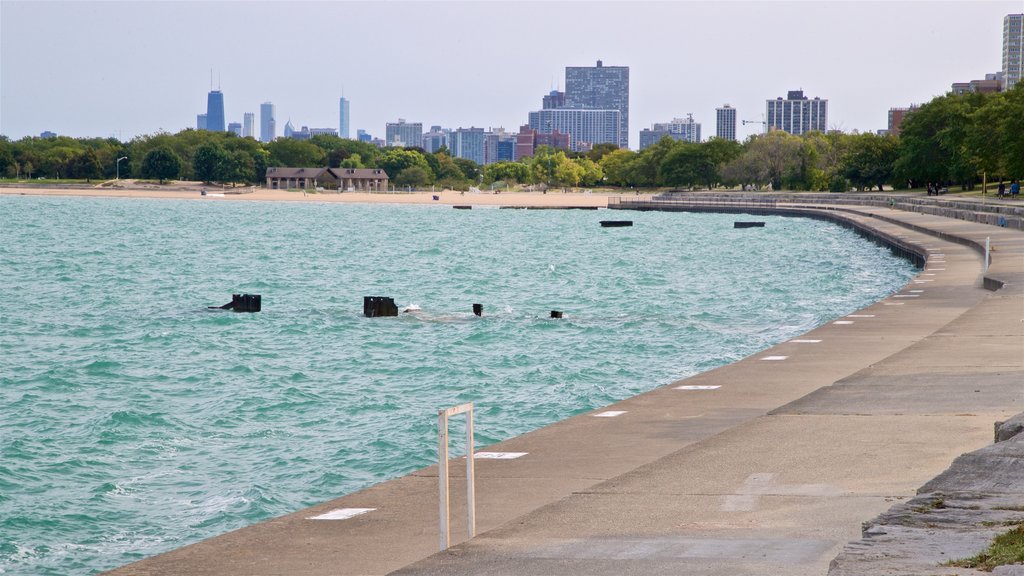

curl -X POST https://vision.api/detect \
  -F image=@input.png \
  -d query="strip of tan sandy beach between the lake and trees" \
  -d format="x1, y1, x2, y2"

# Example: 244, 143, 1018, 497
0, 182, 622, 208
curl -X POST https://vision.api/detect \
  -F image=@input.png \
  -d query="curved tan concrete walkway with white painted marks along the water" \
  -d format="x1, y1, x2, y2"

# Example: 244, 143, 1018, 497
108, 201, 1024, 576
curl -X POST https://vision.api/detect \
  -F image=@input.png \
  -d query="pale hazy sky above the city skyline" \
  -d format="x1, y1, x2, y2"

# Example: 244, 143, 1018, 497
0, 0, 1024, 149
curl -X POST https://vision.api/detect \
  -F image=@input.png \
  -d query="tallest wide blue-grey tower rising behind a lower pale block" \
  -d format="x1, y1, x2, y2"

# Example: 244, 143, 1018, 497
565, 60, 630, 149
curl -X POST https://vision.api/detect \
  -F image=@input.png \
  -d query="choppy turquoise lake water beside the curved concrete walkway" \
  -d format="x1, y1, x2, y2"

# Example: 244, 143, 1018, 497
0, 197, 914, 574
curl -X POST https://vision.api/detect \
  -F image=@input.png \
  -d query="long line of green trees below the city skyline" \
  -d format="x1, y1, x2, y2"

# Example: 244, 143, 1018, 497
0, 83, 1024, 192
